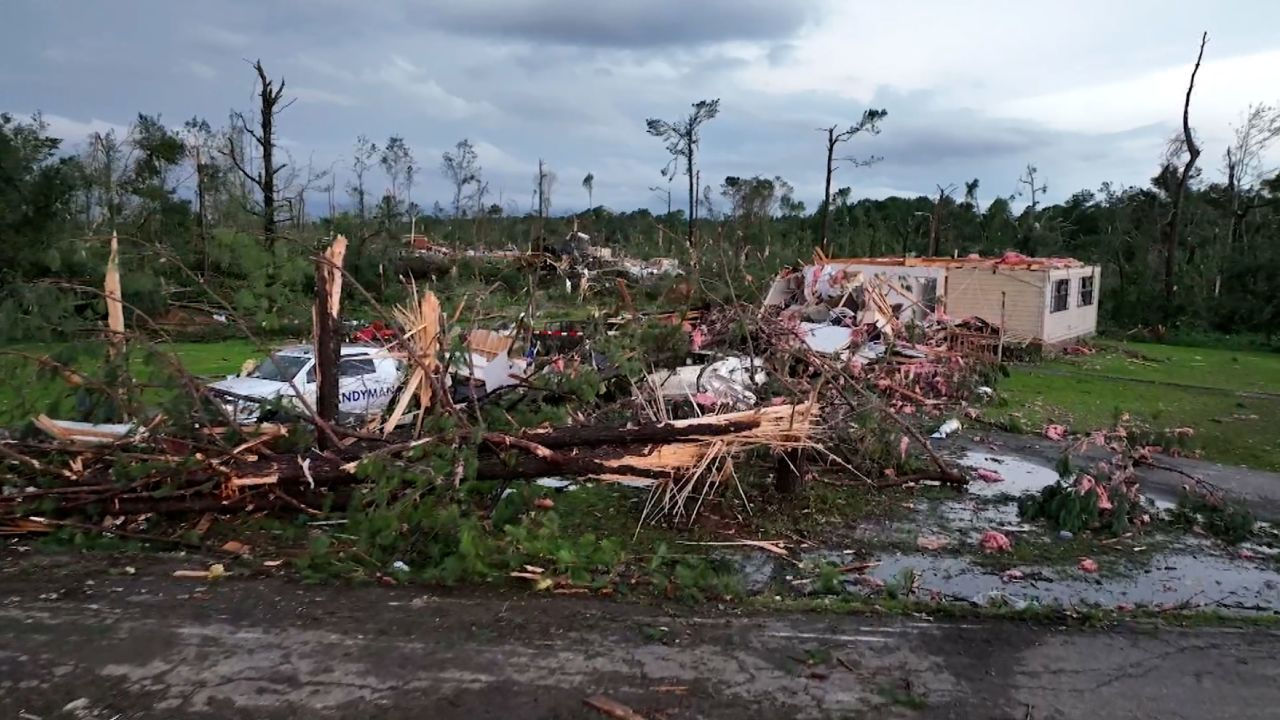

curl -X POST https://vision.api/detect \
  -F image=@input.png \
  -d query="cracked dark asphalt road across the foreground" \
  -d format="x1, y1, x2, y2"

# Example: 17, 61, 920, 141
0, 555, 1280, 720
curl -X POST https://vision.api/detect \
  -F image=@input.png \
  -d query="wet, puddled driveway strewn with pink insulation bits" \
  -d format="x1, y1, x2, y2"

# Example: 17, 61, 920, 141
739, 448, 1280, 614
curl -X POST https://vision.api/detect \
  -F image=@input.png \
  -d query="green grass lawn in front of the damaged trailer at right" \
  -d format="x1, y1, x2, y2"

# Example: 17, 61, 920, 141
987, 342, 1280, 470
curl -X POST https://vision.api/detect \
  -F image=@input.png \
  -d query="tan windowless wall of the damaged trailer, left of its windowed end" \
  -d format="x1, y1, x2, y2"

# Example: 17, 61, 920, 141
945, 266, 1048, 341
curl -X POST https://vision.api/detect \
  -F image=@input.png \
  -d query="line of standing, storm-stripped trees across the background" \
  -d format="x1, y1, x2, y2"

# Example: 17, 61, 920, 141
0, 37, 1280, 340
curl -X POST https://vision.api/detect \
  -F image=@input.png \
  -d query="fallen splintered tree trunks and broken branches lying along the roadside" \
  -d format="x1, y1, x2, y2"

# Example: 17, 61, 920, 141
0, 404, 813, 533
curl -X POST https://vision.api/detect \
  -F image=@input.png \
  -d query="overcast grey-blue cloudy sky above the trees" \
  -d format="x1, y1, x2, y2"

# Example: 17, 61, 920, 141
0, 0, 1280, 211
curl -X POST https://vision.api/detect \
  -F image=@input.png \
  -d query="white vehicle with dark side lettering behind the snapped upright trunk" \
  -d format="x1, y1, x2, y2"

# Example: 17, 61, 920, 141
209, 345, 404, 423
